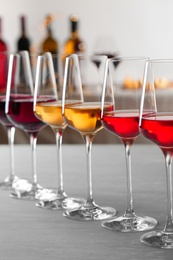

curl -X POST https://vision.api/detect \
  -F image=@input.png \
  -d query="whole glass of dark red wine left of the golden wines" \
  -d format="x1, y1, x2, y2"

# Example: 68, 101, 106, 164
5, 51, 45, 199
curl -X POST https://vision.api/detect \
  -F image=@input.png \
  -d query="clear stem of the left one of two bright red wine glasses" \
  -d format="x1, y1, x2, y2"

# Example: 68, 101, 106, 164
124, 142, 135, 217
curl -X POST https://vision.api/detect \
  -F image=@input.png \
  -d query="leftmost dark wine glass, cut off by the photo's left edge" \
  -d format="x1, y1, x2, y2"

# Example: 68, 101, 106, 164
0, 51, 18, 189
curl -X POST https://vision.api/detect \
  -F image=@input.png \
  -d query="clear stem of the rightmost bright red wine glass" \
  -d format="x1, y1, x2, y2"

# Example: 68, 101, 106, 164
164, 153, 173, 233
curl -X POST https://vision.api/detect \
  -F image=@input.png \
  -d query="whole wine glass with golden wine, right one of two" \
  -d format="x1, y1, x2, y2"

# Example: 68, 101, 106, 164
62, 54, 116, 220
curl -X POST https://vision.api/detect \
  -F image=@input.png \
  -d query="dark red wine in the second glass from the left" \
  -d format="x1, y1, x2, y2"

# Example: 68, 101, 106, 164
7, 95, 45, 133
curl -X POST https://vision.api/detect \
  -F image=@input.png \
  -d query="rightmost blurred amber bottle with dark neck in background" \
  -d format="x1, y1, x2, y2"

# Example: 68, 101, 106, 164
62, 14, 86, 62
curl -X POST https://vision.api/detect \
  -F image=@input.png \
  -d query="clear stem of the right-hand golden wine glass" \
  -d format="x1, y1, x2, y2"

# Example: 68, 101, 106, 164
83, 135, 94, 206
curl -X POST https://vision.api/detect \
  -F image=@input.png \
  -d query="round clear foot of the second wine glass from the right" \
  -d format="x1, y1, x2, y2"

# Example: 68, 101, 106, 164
102, 215, 158, 232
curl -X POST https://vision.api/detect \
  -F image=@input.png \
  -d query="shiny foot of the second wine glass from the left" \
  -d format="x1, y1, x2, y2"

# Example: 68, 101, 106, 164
10, 179, 42, 200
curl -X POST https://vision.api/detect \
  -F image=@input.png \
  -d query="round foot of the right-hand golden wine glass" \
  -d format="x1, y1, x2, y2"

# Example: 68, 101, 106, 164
63, 202, 116, 221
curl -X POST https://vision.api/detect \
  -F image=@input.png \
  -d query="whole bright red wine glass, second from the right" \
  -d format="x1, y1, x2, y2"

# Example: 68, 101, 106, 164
101, 57, 157, 232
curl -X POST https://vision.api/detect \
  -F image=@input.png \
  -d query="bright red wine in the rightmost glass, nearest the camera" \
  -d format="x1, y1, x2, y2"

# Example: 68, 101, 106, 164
140, 113, 173, 153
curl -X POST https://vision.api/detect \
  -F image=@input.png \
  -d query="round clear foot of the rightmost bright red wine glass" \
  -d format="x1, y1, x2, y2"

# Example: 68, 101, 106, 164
140, 230, 173, 249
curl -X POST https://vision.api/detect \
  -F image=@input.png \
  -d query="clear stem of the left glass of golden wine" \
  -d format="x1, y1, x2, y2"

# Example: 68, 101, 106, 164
53, 128, 64, 194
